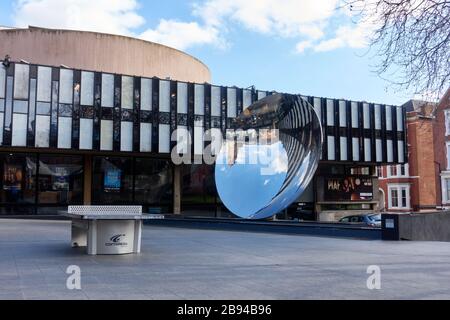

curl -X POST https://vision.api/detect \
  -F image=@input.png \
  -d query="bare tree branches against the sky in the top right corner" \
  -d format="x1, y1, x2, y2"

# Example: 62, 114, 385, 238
344, 0, 450, 99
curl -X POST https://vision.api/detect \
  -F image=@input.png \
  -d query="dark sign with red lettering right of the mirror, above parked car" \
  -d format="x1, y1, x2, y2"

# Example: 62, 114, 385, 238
325, 177, 373, 201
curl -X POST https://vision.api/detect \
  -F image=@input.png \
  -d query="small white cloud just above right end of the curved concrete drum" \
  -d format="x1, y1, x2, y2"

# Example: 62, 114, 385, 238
139, 19, 225, 50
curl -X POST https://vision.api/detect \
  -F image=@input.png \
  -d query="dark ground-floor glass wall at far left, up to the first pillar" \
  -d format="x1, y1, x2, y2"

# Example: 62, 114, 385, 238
0, 153, 83, 215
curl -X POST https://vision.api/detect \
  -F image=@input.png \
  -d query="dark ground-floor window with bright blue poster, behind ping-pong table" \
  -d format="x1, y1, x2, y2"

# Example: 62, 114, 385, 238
92, 157, 133, 205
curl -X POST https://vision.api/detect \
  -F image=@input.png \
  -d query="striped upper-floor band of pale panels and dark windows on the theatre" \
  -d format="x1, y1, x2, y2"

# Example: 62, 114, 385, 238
0, 64, 406, 163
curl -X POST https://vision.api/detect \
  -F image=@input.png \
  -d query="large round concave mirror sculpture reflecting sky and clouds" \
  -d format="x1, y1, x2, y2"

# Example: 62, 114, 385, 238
215, 94, 322, 219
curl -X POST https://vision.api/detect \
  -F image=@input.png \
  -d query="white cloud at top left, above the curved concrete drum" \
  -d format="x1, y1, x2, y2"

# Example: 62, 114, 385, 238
13, 0, 145, 35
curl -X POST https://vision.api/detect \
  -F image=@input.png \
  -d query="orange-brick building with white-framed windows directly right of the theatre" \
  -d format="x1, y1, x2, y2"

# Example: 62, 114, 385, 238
378, 100, 438, 212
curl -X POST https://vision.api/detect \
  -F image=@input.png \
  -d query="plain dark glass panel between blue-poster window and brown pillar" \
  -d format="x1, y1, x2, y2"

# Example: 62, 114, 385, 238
135, 158, 173, 205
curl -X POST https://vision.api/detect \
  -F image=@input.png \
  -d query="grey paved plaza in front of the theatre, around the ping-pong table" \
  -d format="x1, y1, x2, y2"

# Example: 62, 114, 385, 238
0, 219, 450, 300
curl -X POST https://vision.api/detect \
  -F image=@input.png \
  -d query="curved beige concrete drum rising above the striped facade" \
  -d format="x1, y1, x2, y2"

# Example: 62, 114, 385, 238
0, 27, 211, 83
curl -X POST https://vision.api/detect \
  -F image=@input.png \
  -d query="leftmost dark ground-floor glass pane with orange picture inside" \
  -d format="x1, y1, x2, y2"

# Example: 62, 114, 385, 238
0, 154, 36, 204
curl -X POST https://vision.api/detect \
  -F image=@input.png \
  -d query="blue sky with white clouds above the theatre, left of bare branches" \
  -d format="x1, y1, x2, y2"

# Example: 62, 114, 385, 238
0, 0, 413, 104
